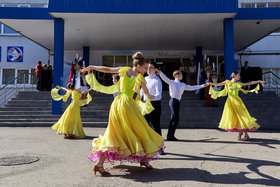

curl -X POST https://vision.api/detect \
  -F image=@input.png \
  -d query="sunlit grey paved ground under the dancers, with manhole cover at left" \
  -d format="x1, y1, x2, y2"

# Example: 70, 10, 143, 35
0, 127, 280, 187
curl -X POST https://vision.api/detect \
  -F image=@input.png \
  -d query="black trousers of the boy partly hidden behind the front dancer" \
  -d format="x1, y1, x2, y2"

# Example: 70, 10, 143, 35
145, 101, 161, 135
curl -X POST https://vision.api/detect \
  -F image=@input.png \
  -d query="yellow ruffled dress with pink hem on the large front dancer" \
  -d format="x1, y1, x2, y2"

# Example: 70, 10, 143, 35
86, 67, 164, 163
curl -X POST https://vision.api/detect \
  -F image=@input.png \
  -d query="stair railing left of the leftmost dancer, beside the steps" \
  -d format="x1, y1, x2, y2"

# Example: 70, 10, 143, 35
0, 72, 35, 108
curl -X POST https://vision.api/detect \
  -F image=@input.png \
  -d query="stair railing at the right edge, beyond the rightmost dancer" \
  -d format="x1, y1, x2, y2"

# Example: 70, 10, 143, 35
263, 70, 280, 96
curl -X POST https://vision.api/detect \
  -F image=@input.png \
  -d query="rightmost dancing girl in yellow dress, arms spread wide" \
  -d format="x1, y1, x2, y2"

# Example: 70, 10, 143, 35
209, 72, 264, 141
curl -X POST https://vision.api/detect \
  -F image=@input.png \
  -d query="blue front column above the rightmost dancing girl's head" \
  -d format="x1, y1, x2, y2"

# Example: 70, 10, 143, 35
224, 18, 235, 79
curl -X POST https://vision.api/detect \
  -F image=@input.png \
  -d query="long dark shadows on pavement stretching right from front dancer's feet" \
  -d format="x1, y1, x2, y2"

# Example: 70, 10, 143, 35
110, 153, 280, 186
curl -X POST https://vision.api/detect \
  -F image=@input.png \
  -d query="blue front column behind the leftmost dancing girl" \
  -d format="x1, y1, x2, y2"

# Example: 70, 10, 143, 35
52, 18, 65, 114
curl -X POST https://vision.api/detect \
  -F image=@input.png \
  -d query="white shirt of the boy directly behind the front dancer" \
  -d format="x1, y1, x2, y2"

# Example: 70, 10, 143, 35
140, 74, 162, 101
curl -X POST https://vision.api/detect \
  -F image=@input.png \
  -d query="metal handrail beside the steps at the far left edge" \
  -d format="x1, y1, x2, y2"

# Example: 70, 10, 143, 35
0, 72, 34, 108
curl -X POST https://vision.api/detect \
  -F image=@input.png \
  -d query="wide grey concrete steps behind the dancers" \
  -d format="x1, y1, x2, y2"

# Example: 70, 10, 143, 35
0, 91, 280, 129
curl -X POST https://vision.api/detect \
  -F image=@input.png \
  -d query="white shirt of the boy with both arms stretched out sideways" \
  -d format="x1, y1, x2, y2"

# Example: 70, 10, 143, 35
159, 72, 204, 101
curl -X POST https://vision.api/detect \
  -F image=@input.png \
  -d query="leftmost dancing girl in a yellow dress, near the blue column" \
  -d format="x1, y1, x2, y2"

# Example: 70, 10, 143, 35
51, 83, 92, 138
